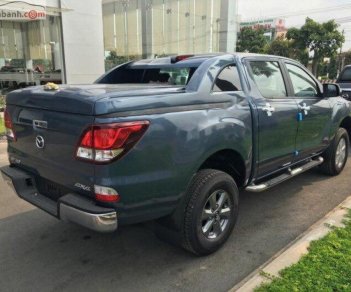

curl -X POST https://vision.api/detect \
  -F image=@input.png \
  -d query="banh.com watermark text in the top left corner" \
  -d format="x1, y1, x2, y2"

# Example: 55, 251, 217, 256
0, 1, 46, 21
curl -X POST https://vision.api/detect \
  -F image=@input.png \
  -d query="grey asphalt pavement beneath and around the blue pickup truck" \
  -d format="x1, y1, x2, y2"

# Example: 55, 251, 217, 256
0, 144, 351, 291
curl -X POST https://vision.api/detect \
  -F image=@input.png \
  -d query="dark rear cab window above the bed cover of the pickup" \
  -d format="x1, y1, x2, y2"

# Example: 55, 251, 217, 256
99, 67, 196, 85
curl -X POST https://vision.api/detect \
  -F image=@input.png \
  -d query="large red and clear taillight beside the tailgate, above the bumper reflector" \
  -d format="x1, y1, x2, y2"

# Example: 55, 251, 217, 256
76, 121, 149, 163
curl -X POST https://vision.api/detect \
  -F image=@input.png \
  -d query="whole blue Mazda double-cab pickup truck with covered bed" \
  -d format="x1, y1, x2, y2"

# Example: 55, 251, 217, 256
1, 54, 351, 255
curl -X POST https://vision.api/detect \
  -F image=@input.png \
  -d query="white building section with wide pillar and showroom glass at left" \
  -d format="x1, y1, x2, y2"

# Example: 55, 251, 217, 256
0, 0, 105, 94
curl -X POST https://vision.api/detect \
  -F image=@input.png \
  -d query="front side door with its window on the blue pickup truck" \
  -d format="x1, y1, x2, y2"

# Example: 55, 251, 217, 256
286, 63, 332, 160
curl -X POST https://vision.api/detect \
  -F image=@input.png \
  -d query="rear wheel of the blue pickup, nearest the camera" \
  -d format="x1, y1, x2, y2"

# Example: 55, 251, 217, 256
181, 169, 239, 255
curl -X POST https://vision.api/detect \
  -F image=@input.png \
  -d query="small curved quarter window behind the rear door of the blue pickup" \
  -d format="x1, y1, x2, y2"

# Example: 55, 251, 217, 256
213, 65, 242, 92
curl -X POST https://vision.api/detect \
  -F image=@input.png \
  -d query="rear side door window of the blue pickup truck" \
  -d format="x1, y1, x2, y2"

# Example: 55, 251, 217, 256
250, 61, 287, 98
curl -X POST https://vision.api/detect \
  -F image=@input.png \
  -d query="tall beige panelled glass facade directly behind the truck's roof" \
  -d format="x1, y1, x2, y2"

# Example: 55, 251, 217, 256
102, 0, 230, 70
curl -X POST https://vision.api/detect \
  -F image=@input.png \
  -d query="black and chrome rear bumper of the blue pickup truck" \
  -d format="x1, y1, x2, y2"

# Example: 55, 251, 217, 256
0, 166, 118, 232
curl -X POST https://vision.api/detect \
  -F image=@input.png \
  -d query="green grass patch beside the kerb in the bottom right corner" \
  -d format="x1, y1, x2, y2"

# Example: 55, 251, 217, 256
255, 211, 351, 292
